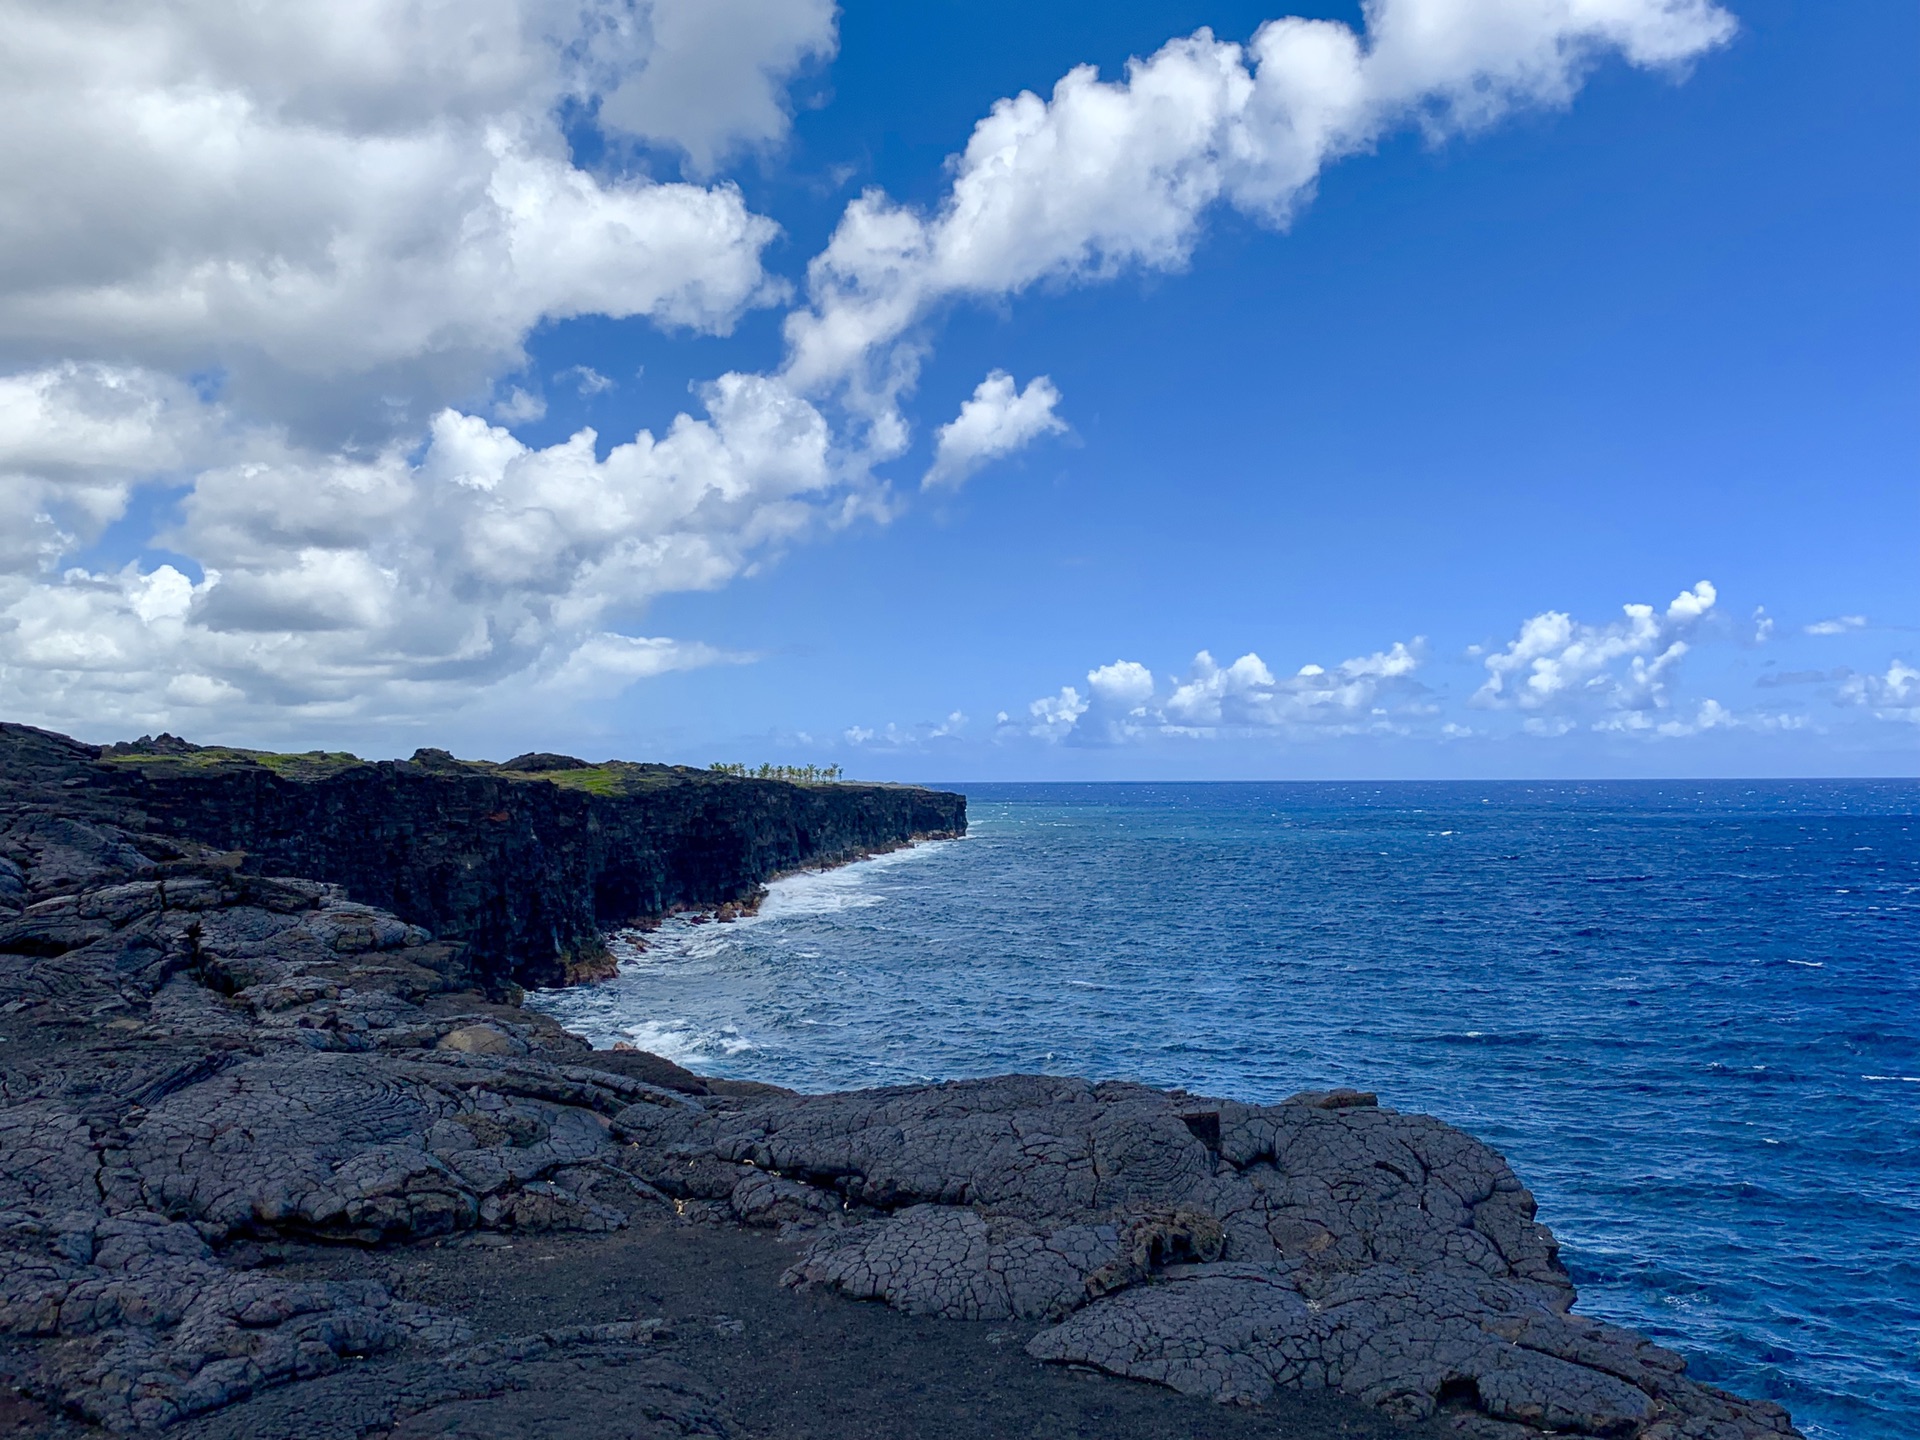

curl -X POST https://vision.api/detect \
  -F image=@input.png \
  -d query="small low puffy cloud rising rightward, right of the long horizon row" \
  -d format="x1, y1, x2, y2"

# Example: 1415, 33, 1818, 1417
1473, 580, 1716, 710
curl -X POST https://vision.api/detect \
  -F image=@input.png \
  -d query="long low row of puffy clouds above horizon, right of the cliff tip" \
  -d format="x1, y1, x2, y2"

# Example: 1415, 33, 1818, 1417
1000, 639, 1428, 745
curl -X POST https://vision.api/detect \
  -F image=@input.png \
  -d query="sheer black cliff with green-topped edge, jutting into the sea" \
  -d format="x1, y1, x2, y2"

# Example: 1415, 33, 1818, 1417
0, 726, 966, 989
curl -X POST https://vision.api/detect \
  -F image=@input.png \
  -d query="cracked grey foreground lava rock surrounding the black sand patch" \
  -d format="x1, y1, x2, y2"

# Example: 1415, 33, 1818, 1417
0, 725, 1793, 1440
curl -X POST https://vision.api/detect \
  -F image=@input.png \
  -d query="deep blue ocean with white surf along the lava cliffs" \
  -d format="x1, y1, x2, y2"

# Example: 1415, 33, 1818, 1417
536, 781, 1920, 1440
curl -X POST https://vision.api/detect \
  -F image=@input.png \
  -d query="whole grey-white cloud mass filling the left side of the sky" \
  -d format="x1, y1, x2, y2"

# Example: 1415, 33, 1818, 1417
0, 0, 856, 730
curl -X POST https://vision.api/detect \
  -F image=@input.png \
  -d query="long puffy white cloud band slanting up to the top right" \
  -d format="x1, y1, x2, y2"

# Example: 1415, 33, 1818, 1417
771, 0, 1734, 422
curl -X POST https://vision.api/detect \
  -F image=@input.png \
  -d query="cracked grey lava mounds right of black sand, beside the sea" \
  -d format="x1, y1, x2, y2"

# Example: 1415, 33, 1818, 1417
614, 1077, 1791, 1440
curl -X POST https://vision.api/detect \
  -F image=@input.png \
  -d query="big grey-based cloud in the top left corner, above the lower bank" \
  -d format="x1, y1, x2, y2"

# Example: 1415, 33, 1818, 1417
0, 0, 791, 436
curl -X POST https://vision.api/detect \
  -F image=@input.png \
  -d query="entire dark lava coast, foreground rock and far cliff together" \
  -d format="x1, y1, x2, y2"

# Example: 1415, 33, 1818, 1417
0, 726, 1795, 1440
